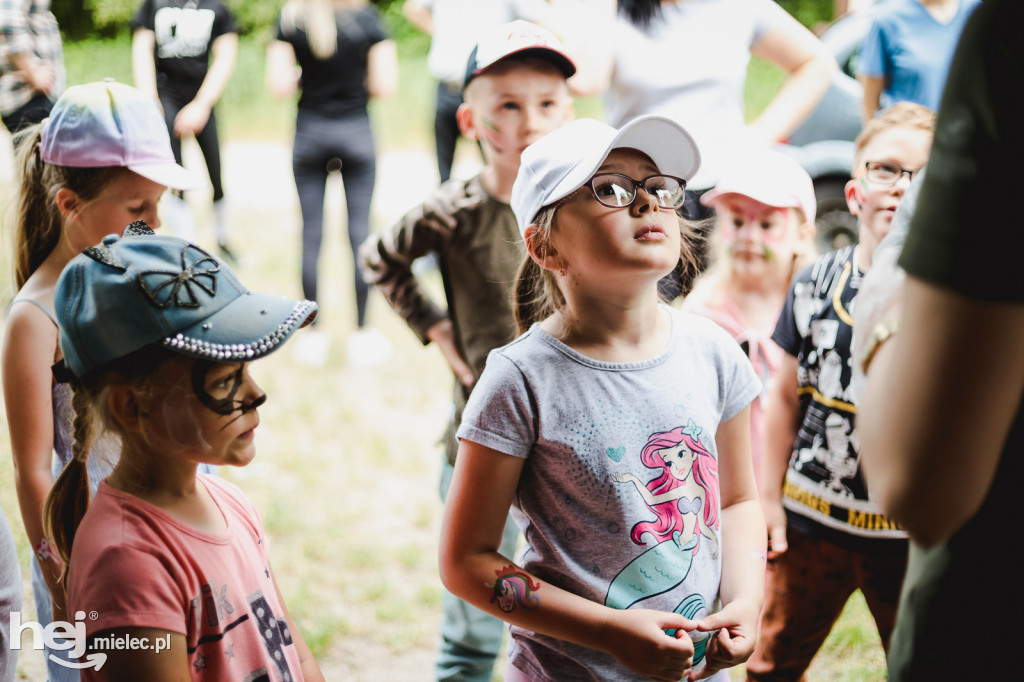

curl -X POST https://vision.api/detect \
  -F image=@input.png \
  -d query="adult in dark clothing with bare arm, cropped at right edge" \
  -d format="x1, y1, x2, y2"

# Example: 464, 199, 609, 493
856, 0, 1024, 682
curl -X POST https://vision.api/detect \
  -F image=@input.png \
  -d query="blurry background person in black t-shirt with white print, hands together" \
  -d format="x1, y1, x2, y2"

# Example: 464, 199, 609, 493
131, 0, 239, 260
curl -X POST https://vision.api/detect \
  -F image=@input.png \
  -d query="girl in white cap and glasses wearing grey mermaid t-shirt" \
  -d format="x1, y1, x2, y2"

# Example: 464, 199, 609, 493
439, 117, 765, 682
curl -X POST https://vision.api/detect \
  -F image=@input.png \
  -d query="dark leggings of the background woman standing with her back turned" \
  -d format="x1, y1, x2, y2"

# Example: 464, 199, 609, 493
292, 111, 377, 327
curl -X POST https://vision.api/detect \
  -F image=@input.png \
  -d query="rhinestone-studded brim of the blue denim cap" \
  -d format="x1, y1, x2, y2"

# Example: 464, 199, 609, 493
164, 292, 317, 361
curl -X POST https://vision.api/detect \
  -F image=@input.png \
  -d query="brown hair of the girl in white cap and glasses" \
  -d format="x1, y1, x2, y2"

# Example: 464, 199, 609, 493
512, 204, 705, 334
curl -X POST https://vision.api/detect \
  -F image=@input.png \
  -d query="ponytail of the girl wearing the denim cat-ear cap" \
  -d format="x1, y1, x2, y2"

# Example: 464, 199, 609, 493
43, 384, 96, 589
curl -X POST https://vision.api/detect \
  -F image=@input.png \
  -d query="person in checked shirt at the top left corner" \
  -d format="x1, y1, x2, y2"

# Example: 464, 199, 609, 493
0, 0, 65, 134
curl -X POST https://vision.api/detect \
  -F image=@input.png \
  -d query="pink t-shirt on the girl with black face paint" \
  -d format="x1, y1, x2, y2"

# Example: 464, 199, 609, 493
68, 474, 303, 682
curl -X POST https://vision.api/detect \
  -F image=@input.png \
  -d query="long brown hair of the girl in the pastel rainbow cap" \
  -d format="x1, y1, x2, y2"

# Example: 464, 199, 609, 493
14, 124, 127, 289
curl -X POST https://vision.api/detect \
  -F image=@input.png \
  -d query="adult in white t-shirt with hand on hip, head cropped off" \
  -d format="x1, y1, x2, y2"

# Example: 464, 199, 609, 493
570, 0, 837, 297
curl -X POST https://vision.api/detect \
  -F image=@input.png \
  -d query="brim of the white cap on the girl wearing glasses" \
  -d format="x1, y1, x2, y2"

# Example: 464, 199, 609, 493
548, 115, 700, 205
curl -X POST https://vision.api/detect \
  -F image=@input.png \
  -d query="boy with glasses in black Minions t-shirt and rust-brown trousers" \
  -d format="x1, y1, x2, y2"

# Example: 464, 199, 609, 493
746, 102, 935, 681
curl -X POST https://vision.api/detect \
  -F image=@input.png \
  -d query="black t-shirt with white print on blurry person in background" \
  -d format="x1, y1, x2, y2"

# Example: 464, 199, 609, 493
131, 0, 238, 101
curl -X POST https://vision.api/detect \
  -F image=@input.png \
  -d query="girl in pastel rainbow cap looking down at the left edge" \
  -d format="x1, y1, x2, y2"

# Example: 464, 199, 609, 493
3, 81, 202, 681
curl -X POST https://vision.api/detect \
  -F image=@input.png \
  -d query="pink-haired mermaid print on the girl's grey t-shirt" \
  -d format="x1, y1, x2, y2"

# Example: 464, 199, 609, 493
605, 420, 720, 664
